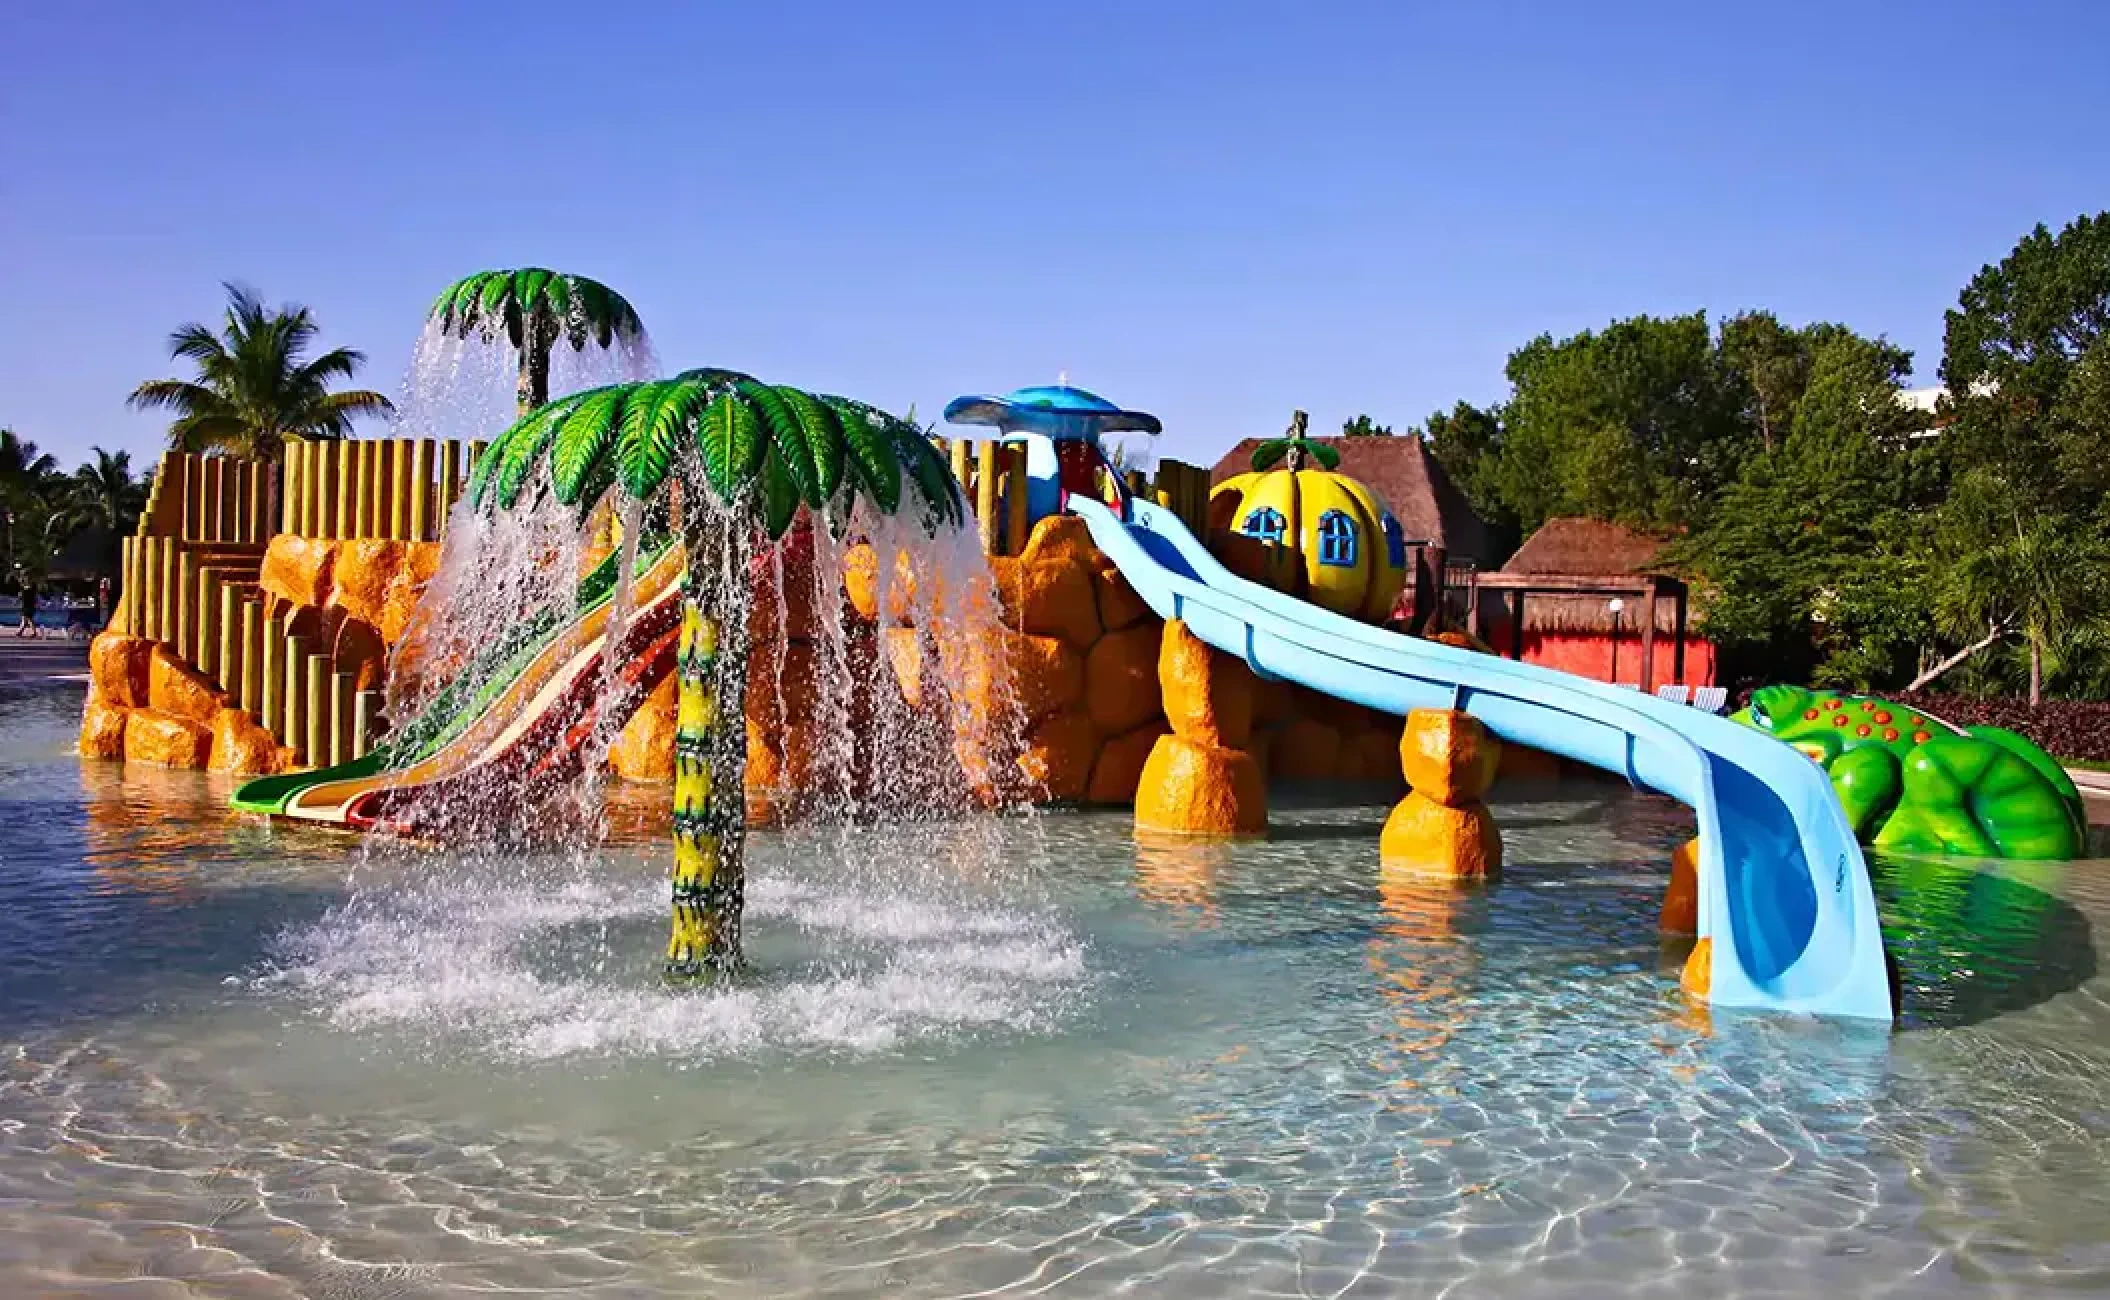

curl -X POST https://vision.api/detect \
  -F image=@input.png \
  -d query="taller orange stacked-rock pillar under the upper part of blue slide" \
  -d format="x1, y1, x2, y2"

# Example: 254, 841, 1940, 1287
1135, 618, 1268, 836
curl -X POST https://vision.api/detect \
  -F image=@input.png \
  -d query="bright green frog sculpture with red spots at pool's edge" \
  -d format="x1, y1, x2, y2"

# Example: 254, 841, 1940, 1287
1734, 686, 2087, 859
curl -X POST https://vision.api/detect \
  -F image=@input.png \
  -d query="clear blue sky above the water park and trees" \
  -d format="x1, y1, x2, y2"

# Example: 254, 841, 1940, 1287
0, 0, 2110, 472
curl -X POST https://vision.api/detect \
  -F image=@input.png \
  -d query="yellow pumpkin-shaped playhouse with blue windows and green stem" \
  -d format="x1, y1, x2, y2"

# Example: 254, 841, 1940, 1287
1209, 412, 1407, 623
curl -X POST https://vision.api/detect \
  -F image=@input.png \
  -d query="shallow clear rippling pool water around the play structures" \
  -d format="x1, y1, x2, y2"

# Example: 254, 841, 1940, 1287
0, 686, 2110, 1300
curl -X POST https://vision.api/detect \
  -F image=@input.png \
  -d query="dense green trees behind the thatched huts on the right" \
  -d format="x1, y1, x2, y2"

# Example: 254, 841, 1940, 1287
1344, 213, 2110, 703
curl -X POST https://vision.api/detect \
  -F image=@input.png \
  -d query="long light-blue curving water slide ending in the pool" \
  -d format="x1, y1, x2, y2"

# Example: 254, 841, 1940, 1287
1063, 496, 1891, 1019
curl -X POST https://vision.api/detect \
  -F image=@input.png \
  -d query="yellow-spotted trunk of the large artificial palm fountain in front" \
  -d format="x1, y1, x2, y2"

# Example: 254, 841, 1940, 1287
667, 563, 747, 979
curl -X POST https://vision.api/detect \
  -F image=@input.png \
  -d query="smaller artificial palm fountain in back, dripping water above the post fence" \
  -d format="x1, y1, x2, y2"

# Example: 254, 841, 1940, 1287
426, 266, 644, 416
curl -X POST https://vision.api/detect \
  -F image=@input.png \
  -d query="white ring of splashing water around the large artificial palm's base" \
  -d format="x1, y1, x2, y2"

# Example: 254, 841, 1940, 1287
255, 827, 1089, 1064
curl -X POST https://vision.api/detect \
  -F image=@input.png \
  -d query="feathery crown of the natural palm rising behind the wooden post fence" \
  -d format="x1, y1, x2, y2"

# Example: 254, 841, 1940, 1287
127, 285, 395, 460
